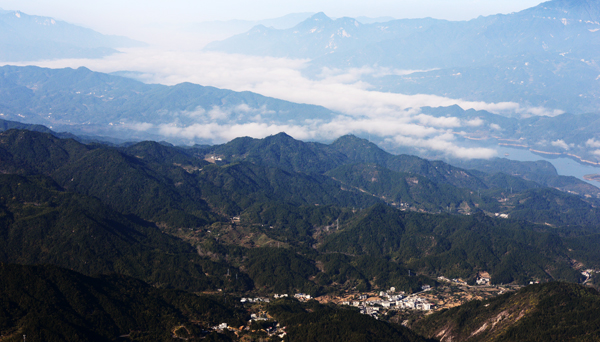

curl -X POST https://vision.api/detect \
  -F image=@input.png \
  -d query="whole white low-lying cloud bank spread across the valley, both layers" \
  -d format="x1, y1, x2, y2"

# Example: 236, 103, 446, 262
4, 49, 560, 158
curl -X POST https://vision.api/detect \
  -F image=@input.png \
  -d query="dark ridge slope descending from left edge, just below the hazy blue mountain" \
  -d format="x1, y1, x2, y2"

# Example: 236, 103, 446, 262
0, 130, 215, 226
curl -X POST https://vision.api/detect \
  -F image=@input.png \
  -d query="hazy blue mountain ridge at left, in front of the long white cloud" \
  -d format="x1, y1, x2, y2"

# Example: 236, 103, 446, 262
0, 66, 334, 140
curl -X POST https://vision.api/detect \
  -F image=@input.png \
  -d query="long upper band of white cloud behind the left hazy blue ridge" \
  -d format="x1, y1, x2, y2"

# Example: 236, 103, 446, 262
10, 49, 556, 120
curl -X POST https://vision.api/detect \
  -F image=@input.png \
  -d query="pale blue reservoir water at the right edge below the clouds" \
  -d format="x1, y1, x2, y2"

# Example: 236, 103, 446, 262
496, 146, 600, 187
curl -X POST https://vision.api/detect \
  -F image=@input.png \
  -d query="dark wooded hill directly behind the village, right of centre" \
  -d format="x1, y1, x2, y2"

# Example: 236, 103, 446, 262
319, 205, 597, 283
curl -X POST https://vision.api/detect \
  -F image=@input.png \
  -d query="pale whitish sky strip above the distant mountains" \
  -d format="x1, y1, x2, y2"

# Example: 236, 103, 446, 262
0, 0, 541, 39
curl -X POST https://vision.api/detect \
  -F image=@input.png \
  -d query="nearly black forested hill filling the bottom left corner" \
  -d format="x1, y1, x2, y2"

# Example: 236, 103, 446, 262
0, 263, 249, 342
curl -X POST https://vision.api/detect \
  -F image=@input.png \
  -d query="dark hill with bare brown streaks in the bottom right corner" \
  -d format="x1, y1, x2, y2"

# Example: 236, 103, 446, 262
412, 283, 600, 342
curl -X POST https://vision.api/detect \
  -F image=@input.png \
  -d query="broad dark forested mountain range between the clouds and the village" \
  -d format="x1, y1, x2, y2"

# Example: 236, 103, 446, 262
0, 129, 600, 294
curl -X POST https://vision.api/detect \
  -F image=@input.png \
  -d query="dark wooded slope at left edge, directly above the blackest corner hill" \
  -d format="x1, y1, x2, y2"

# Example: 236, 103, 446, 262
0, 175, 252, 291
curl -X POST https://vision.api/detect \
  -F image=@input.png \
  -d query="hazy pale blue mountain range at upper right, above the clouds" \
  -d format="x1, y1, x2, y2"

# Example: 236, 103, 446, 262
205, 0, 600, 113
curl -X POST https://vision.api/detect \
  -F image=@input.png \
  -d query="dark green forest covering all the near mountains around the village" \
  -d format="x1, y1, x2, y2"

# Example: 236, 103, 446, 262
0, 127, 600, 341
